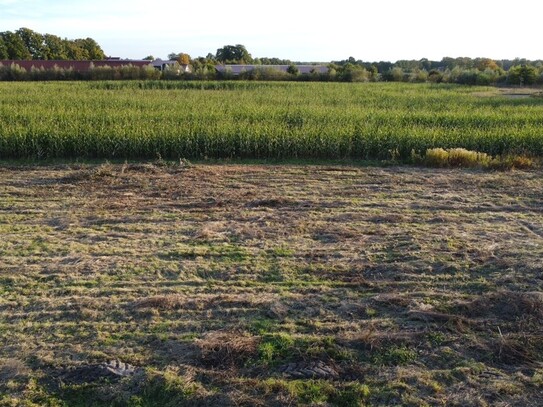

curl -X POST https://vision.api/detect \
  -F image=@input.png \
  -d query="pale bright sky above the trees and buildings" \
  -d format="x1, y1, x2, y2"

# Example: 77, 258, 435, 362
0, 0, 543, 62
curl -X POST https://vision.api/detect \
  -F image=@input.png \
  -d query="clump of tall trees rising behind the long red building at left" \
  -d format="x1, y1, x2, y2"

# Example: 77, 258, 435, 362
0, 27, 106, 61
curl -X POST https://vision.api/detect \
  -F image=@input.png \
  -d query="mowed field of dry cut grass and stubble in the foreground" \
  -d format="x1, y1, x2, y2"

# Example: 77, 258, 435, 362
0, 163, 543, 406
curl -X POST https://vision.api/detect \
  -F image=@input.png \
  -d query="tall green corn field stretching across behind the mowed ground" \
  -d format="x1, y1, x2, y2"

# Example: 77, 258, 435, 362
0, 81, 543, 159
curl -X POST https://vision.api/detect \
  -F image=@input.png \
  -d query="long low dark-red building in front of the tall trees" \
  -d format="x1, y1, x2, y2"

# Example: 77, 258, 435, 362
0, 58, 151, 72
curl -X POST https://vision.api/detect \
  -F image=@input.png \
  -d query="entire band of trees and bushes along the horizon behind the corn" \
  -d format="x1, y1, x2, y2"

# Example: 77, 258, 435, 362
0, 28, 543, 86
